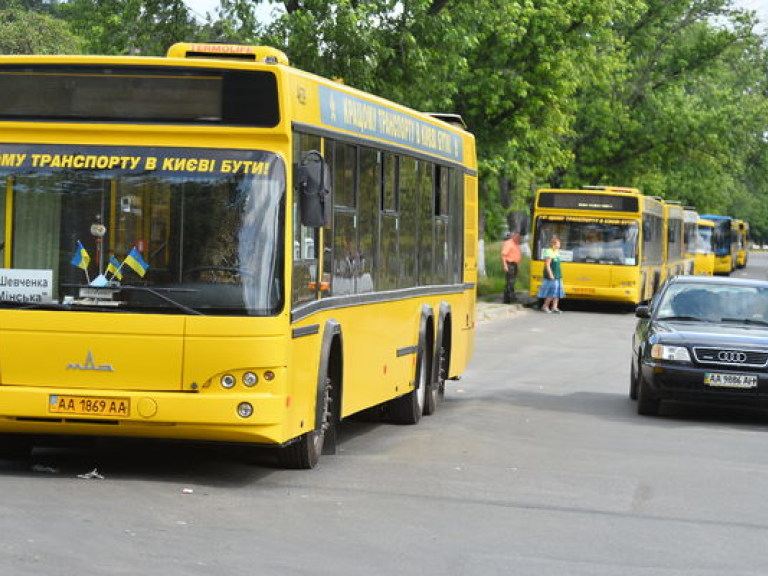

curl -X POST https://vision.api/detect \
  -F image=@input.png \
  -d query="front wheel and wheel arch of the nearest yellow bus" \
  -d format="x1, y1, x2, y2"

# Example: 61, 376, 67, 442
279, 320, 343, 469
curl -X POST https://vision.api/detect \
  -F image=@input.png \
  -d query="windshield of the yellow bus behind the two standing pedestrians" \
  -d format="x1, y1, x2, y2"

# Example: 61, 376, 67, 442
534, 216, 638, 266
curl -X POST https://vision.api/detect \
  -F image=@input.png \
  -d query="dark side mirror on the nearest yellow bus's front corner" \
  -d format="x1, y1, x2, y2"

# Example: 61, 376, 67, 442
294, 150, 331, 228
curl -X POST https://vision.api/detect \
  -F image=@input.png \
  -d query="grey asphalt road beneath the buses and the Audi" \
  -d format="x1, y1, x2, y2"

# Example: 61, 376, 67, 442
0, 254, 768, 576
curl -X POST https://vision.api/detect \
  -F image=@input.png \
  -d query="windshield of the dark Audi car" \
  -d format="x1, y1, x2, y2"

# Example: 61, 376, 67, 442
656, 283, 768, 325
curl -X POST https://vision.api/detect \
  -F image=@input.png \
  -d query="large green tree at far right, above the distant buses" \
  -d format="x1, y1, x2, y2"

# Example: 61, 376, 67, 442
553, 0, 766, 213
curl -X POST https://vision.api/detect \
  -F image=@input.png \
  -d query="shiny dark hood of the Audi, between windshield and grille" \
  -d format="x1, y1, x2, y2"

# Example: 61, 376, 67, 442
651, 321, 768, 347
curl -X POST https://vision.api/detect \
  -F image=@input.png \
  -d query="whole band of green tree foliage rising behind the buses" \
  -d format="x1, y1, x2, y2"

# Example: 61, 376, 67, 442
7, 0, 768, 241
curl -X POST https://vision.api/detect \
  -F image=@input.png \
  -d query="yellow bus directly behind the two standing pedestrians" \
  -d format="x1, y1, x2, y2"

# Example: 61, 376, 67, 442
530, 186, 664, 304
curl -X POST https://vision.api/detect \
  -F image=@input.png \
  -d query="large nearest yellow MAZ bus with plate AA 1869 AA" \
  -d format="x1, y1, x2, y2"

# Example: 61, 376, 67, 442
0, 44, 478, 468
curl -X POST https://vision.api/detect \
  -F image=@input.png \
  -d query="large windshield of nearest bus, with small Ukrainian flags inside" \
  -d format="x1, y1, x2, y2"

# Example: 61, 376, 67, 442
0, 145, 286, 315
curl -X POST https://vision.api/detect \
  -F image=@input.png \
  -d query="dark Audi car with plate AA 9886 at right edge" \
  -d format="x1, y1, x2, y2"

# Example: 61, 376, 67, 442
629, 276, 768, 415
